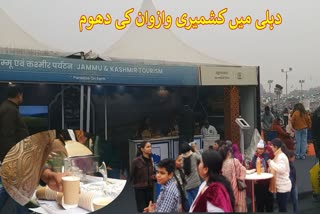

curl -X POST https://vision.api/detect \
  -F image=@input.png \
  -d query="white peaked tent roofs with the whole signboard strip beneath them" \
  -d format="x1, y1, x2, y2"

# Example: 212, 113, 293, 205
0, 0, 259, 85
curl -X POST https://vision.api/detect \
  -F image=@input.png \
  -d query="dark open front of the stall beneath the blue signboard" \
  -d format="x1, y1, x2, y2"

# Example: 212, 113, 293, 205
0, 83, 224, 176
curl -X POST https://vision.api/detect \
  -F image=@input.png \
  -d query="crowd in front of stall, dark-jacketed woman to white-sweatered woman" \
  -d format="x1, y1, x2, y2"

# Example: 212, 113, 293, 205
131, 135, 298, 213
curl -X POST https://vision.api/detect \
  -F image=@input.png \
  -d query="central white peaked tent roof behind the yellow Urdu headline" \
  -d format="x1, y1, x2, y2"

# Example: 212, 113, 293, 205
100, 0, 234, 65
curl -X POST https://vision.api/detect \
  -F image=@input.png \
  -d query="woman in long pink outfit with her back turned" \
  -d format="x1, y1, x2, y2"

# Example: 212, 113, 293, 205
219, 145, 247, 212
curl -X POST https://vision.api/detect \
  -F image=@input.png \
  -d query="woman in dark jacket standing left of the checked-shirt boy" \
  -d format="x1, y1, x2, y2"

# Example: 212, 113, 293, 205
130, 141, 155, 212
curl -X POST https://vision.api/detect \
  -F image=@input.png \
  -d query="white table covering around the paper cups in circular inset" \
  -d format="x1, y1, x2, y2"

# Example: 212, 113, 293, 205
30, 175, 126, 214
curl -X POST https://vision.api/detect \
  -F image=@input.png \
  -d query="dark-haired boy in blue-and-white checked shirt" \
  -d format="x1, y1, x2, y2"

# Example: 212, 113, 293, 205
144, 158, 180, 213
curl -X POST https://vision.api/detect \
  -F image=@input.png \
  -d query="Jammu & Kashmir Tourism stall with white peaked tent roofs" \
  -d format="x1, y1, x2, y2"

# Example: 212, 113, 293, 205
0, 1, 260, 185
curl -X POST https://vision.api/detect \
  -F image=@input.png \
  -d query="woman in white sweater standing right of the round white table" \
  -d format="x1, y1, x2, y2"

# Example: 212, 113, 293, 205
268, 138, 292, 212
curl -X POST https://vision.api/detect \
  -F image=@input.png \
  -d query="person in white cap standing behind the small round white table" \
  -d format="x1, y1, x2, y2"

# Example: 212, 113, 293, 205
249, 140, 273, 212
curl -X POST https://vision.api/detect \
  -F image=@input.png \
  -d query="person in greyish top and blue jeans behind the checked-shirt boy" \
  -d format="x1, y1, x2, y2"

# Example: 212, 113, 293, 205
180, 143, 201, 205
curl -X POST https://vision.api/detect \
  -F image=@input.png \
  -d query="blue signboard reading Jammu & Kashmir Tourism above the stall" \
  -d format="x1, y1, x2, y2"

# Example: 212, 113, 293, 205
0, 54, 199, 85
